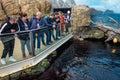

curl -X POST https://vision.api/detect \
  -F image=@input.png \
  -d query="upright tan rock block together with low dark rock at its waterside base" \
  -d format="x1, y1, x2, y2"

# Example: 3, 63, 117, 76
71, 5, 109, 39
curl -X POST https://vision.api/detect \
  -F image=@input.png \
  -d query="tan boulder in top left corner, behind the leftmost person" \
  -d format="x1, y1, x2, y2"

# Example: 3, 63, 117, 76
0, 0, 20, 20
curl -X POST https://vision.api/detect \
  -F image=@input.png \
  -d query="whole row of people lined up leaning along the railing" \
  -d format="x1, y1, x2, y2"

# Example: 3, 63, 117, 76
0, 11, 70, 65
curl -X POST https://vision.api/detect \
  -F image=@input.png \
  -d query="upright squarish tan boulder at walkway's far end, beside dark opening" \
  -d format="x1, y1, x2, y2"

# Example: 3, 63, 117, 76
71, 5, 90, 29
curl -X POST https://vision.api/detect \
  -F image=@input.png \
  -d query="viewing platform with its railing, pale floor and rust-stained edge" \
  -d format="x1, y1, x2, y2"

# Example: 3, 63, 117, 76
0, 27, 73, 78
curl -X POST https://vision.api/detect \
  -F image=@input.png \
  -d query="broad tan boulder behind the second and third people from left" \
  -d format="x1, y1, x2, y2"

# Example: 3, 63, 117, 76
20, 0, 51, 17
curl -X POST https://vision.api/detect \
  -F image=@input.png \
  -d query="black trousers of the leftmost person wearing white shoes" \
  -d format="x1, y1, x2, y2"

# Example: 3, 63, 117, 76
1, 39, 15, 58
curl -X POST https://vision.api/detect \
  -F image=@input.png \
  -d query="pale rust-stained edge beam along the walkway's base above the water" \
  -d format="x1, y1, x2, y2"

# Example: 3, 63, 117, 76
0, 33, 73, 78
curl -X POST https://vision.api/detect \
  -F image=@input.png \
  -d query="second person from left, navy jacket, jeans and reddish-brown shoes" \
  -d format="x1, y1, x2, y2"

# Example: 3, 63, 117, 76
18, 13, 32, 58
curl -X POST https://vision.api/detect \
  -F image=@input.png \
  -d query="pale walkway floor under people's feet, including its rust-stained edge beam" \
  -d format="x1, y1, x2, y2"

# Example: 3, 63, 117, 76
0, 27, 73, 77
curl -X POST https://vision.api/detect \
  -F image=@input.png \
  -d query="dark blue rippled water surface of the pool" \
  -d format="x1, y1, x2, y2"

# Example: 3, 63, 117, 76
53, 40, 120, 80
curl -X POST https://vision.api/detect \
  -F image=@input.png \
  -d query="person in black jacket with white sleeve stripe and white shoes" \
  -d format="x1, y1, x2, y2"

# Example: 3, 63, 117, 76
0, 16, 19, 65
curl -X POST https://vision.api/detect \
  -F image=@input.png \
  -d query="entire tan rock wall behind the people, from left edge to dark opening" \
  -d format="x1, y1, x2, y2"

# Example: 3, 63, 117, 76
0, 0, 51, 20
